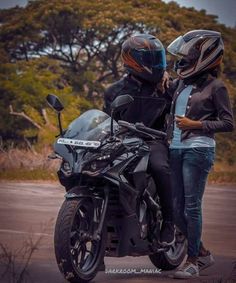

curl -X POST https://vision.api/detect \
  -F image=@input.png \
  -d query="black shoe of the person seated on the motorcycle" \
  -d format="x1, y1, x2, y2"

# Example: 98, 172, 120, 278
159, 221, 175, 246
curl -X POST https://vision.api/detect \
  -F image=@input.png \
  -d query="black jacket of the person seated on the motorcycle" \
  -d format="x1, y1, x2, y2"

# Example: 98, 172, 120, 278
103, 75, 171, 130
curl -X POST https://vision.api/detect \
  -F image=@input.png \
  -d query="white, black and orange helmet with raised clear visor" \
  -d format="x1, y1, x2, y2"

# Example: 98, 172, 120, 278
167, 30, 224, 79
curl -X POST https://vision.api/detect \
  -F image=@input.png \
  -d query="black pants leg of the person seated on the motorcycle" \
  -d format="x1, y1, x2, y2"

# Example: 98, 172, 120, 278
148, 141, 173, 221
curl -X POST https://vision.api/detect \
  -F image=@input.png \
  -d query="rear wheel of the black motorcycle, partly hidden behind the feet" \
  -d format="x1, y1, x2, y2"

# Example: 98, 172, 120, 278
149, 231, 187, 270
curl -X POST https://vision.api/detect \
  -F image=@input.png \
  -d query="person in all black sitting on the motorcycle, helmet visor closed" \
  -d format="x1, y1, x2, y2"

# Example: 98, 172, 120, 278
104, 34, 175, 245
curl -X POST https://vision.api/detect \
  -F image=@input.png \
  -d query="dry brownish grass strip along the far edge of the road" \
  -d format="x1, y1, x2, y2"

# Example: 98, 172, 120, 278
0, 147, 236, 184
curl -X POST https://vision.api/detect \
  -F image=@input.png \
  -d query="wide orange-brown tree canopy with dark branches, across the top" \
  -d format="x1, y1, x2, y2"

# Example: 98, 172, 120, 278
0, 0, 236, 82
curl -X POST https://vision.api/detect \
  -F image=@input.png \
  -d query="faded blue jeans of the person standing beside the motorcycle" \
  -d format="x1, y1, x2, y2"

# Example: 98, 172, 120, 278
170, 147, 215, 257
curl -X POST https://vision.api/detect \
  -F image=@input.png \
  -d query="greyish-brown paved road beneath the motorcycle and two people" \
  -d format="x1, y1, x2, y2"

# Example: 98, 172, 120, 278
0, 182, 236, 283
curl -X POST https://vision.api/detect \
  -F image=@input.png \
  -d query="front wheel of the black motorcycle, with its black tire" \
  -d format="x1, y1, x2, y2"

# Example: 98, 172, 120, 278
54, 198, 106, 283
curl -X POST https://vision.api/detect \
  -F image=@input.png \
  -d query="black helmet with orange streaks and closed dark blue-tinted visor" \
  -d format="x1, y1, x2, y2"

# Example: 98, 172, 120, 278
121, 34, 166, 83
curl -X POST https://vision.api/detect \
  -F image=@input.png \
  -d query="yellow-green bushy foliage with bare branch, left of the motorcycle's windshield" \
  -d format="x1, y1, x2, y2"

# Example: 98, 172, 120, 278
0, 57, 92, 146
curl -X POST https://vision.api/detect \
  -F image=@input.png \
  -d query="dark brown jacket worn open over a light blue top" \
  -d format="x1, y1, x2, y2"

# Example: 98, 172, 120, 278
167, 73, 234, 142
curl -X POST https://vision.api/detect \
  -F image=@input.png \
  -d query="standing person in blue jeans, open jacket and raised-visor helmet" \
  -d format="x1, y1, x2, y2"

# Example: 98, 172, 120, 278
167, 30, 234, 279
